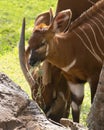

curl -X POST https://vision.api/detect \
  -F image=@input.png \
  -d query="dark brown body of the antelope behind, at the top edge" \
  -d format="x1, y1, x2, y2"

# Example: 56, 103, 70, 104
56, 0, 99, 21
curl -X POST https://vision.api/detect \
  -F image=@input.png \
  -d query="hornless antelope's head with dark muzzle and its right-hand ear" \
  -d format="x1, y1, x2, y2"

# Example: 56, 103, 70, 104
28, 9, 72, 66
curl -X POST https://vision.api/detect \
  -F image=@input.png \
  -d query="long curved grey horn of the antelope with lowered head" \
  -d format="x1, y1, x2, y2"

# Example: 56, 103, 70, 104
19, 18, 35, 88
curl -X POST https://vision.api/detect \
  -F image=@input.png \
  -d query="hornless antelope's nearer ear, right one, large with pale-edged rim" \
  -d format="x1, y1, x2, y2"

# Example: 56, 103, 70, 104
50, 9, 72, 33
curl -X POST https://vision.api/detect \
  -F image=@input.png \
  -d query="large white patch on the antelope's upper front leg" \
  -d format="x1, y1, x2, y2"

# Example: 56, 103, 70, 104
68, 82, 84, 98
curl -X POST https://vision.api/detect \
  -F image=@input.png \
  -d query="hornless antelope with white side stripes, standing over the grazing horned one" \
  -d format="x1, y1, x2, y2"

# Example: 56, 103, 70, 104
29, 0, 104, 120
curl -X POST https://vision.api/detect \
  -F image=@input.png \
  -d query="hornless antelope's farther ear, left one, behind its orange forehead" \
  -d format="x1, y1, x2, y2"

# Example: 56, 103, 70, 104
35, 9, 53, 26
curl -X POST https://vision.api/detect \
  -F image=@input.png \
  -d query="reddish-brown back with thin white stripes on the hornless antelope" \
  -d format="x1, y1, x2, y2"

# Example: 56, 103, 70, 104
69, 0, 104, 63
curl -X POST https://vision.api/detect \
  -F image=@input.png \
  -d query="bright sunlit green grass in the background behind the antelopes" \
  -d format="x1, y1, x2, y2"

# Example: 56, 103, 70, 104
0, 0, 90, 125
